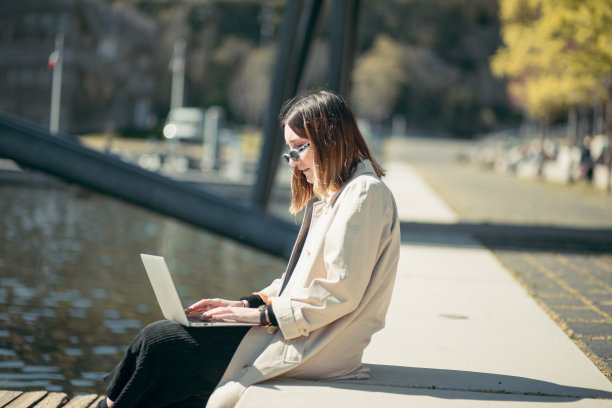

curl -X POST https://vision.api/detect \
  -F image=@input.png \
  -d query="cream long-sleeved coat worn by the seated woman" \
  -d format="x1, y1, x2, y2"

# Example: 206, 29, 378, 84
207, 160, 400, 408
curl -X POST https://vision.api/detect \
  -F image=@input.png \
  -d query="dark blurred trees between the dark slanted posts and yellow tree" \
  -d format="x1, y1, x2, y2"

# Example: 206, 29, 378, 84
353, 0, 516, 137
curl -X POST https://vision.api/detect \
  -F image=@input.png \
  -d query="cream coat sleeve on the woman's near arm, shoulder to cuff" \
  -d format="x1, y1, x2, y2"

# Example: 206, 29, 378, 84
271, 177, 393, 340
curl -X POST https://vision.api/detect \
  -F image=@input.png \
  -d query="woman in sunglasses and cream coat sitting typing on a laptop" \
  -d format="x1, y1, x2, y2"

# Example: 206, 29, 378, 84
100, 91, 400, 408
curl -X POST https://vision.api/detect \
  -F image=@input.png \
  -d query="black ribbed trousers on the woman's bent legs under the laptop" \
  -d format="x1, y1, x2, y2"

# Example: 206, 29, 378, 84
104, 320, 249, 408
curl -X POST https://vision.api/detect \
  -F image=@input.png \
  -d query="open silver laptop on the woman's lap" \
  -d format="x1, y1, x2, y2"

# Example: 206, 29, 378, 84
140, 254, 257, 327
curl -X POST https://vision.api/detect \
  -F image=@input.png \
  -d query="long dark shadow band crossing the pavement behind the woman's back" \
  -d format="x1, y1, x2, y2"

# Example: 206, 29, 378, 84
401, 222, 612, 254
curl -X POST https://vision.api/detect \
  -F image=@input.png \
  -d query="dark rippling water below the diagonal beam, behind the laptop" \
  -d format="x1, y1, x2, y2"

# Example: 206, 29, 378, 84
0, 178, 285, 395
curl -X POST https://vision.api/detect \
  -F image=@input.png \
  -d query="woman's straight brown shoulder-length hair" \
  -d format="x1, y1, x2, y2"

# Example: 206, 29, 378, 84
280, 91, 385, 214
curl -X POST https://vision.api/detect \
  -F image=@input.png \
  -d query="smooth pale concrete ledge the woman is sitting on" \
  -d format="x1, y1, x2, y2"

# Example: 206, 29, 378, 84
238, 139, 612, 408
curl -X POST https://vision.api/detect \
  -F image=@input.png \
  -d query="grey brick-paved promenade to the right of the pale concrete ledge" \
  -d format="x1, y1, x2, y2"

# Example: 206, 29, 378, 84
387, 138, 612, 380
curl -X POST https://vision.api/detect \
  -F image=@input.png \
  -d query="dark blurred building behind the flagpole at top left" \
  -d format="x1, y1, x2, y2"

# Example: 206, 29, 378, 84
0, 0, 157, 134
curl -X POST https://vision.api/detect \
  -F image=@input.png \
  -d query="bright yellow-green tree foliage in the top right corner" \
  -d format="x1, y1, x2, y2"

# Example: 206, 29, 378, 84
491, 0, 612, 121
